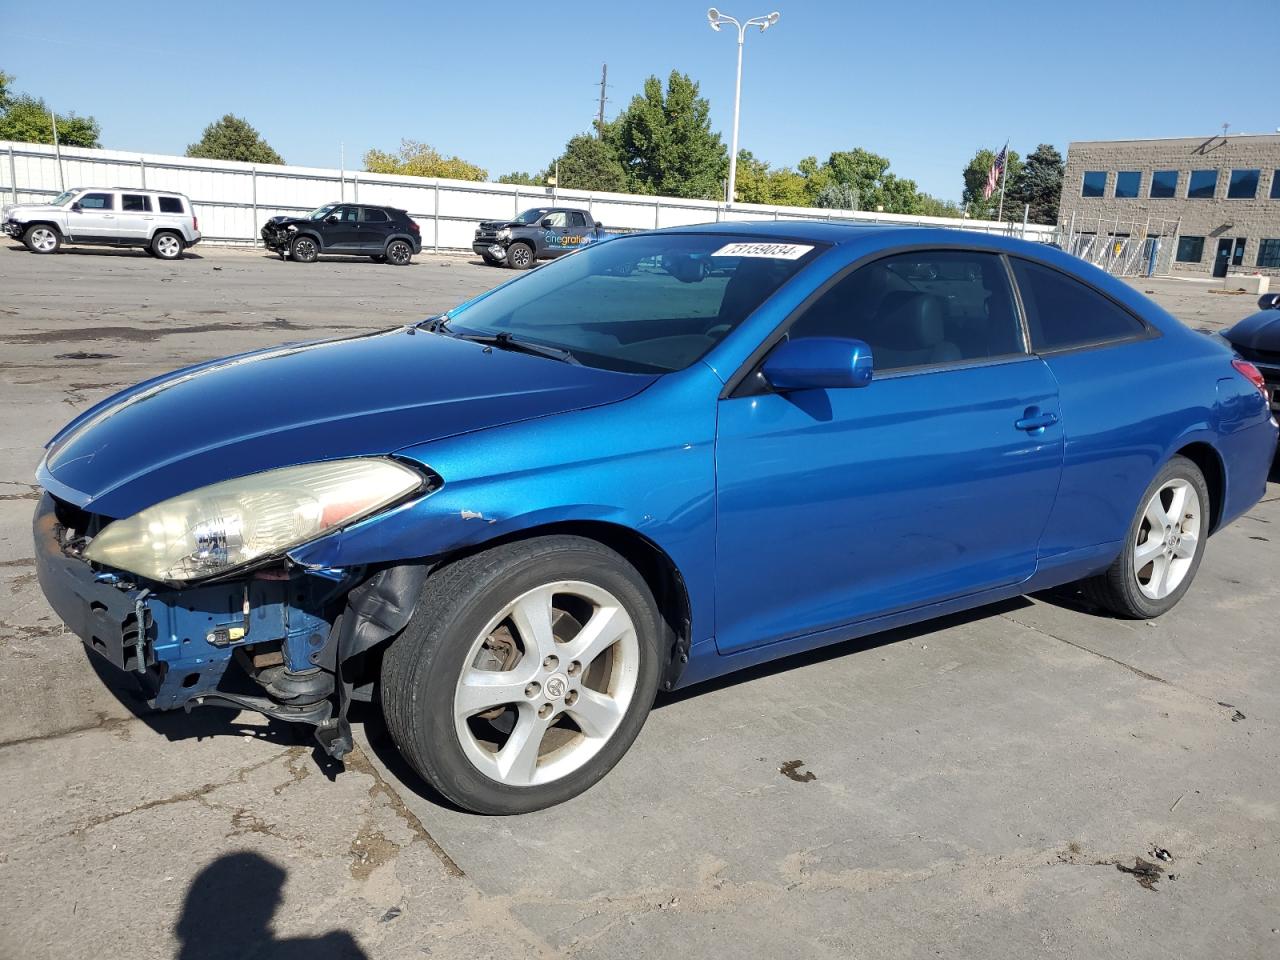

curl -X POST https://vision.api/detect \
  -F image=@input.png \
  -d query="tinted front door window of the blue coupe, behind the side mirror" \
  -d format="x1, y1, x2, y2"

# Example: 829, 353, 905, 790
787, 250, 1023, 371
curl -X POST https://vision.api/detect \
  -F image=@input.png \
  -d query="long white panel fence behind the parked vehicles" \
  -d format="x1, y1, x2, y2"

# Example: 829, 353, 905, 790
0, 141, 1055, 250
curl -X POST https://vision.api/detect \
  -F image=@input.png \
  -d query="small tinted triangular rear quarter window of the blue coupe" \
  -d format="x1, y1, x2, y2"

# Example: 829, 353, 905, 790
1012, 257, 1146, 351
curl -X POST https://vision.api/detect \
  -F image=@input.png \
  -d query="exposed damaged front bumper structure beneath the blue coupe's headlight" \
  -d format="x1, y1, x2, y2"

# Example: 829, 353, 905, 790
33, 493, 428, 758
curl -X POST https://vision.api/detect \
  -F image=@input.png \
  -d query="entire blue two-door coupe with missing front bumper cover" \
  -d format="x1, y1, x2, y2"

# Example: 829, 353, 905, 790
35, 223, 1276, 814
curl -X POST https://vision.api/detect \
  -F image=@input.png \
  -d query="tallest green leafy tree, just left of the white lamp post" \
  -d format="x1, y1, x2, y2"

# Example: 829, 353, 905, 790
603, 70, 728, 200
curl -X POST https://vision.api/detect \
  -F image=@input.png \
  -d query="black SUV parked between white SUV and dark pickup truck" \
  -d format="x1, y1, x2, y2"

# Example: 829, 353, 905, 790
262, 204, 422, 266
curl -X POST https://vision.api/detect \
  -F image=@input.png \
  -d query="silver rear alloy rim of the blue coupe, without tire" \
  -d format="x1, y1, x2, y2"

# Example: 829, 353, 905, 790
1133, 477, 1202, 600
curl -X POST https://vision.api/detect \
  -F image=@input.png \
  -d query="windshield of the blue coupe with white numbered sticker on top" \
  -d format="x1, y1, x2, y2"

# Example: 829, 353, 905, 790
447, 233, 820, 372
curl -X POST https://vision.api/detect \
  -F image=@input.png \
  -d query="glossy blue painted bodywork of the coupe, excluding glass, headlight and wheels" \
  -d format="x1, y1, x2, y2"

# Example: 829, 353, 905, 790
38, 224, 1276, 721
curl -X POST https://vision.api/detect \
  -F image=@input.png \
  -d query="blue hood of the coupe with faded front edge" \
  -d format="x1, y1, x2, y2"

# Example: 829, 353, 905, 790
37, 328, 655, 527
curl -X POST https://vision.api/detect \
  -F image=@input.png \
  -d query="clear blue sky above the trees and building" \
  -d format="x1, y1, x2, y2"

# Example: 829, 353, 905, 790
0, 0, 1280, 200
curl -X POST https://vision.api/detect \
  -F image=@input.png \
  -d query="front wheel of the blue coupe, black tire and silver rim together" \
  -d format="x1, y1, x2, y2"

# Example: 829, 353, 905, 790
381, 536, 660, 814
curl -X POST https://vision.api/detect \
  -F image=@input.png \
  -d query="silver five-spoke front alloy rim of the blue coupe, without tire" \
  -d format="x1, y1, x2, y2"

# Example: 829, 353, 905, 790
453, 580, 640, 787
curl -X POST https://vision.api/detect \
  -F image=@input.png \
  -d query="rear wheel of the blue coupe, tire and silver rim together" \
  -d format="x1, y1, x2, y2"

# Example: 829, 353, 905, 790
1082, 457, 1211, 620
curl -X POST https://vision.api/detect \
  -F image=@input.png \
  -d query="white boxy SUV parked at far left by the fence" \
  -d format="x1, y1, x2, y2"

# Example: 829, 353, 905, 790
0, 187, 200, 260
